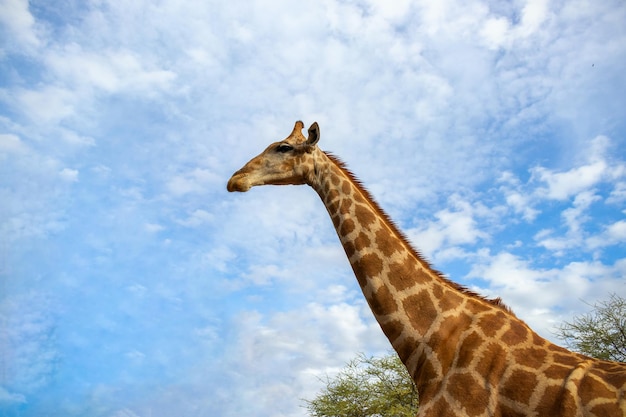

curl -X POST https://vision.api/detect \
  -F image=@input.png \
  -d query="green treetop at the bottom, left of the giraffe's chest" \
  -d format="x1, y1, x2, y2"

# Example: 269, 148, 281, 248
305, 353, 418, 417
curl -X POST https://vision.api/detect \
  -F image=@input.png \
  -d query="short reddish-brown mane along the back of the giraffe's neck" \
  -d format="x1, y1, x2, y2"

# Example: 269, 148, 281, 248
324, 152, 515, 315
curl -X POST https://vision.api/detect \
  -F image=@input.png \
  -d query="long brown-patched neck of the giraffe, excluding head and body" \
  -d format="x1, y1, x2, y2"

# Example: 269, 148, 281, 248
310, 153, 472, 380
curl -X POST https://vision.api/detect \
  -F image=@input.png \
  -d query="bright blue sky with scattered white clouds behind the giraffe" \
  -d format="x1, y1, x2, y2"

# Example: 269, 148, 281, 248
0, 0, 626, 417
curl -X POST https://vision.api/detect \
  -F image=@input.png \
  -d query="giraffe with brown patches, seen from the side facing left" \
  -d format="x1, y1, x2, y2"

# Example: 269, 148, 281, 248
227, 121, 626, 417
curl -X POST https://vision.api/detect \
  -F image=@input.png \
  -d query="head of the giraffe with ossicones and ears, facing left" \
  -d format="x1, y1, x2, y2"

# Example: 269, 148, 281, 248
226, 121, 320, 192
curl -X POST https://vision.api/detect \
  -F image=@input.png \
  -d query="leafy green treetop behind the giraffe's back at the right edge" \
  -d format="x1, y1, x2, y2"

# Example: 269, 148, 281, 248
556, 294, 626, 362
